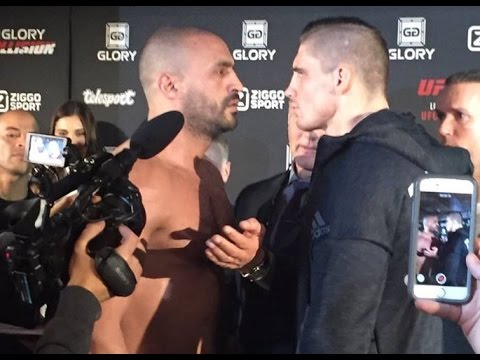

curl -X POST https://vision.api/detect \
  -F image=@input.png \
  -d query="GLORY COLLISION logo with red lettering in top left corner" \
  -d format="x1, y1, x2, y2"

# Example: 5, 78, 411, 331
0, 28, 57, 55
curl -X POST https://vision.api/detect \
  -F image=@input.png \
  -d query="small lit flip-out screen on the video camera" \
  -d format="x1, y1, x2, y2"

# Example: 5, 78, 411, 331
25, 133, 68, 167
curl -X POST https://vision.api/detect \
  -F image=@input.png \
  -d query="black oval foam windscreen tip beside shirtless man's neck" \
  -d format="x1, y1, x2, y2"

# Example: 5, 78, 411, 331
130, 111, 184, 159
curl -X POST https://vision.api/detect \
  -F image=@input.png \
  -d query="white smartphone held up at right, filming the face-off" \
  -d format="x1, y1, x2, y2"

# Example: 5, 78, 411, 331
408, 175, 477, 303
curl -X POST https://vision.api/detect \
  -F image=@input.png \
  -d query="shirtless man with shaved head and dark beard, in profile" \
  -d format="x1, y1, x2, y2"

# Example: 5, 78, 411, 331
92, 28, 242, 354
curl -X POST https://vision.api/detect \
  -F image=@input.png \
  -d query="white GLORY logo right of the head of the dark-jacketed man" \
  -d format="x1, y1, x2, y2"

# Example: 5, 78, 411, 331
388, 17, 435, 61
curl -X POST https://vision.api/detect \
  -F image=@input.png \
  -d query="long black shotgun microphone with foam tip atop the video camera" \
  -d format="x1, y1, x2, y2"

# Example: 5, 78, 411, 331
47, 111, 184, 202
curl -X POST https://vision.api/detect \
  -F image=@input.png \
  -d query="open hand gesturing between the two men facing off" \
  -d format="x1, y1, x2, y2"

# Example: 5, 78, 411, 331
205, 218, 265, 270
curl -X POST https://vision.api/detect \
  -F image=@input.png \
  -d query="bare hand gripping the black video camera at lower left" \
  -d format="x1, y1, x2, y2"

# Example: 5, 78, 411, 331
68, 221, 144, 302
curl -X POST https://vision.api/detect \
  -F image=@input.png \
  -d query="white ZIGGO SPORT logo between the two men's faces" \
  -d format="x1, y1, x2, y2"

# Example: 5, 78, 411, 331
237, 87, 285, 111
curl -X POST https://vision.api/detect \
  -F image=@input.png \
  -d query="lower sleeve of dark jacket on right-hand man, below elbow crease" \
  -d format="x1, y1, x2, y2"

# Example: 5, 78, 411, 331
298, 239, 392, 354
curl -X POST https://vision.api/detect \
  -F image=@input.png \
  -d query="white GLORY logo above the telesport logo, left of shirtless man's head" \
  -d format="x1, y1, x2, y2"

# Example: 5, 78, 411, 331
97, 22, 137, 62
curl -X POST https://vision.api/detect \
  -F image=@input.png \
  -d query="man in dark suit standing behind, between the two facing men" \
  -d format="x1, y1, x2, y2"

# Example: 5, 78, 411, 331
207, 105, 323, 353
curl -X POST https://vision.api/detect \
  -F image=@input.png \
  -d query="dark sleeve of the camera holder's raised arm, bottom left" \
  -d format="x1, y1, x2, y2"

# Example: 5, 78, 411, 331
36, 286, 101, 354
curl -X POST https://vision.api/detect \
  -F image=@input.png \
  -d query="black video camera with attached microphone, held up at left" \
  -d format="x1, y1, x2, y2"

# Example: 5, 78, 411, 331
0, 111, 184, 327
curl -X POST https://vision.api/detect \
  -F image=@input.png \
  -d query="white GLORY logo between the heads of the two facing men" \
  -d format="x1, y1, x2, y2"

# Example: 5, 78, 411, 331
232, 20, 277, 61
